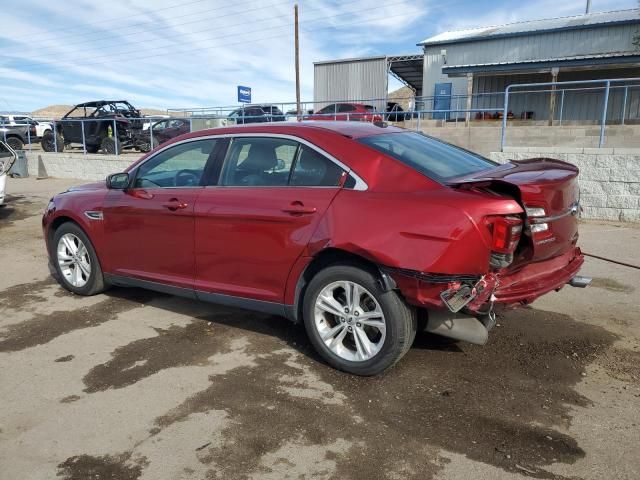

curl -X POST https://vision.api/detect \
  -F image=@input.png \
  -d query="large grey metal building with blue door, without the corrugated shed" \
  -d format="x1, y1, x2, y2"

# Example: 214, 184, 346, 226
418, 9, 640, 119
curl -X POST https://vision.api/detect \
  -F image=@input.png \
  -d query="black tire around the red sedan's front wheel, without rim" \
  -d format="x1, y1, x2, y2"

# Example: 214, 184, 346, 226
50, 222, 106, 296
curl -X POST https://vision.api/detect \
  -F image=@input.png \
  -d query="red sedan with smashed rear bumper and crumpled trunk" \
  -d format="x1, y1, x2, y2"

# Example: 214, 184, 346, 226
43, 122, 589, 375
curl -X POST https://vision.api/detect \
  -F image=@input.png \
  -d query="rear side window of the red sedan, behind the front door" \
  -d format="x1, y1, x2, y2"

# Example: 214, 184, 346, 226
220, 137, 344, 187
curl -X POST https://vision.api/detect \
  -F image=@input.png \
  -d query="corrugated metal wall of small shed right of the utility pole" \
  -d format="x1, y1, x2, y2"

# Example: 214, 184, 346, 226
313, 57, 388, 111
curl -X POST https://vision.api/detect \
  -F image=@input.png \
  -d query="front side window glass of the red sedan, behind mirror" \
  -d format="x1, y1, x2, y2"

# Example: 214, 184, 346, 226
134, 139, 217, 188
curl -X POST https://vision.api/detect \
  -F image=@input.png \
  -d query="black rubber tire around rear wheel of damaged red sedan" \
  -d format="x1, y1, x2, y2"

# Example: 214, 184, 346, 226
303, 264, 417, 376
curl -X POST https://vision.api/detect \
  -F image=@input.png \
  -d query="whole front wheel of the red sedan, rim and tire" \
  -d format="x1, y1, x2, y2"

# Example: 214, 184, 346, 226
51, 222, 105, 295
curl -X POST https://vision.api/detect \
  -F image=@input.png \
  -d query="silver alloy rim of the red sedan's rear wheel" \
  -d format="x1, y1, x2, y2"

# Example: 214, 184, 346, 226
314, 281, 387, 362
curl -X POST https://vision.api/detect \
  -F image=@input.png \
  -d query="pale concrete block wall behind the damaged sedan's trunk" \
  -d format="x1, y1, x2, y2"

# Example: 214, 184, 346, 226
490, 147, 640, 222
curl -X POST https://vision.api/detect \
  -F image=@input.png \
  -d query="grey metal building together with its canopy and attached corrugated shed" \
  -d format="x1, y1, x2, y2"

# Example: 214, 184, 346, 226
314, 9, 640, 121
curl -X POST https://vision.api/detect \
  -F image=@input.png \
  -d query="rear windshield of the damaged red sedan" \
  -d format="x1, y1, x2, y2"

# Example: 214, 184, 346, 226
358, 132, 498, 181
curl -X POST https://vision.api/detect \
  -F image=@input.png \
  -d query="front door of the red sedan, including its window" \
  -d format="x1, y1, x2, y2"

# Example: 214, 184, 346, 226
104, 138, 224, 289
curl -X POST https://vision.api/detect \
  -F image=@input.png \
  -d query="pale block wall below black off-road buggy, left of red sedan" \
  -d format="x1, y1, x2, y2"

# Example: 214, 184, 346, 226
27, 152, 140, 180
